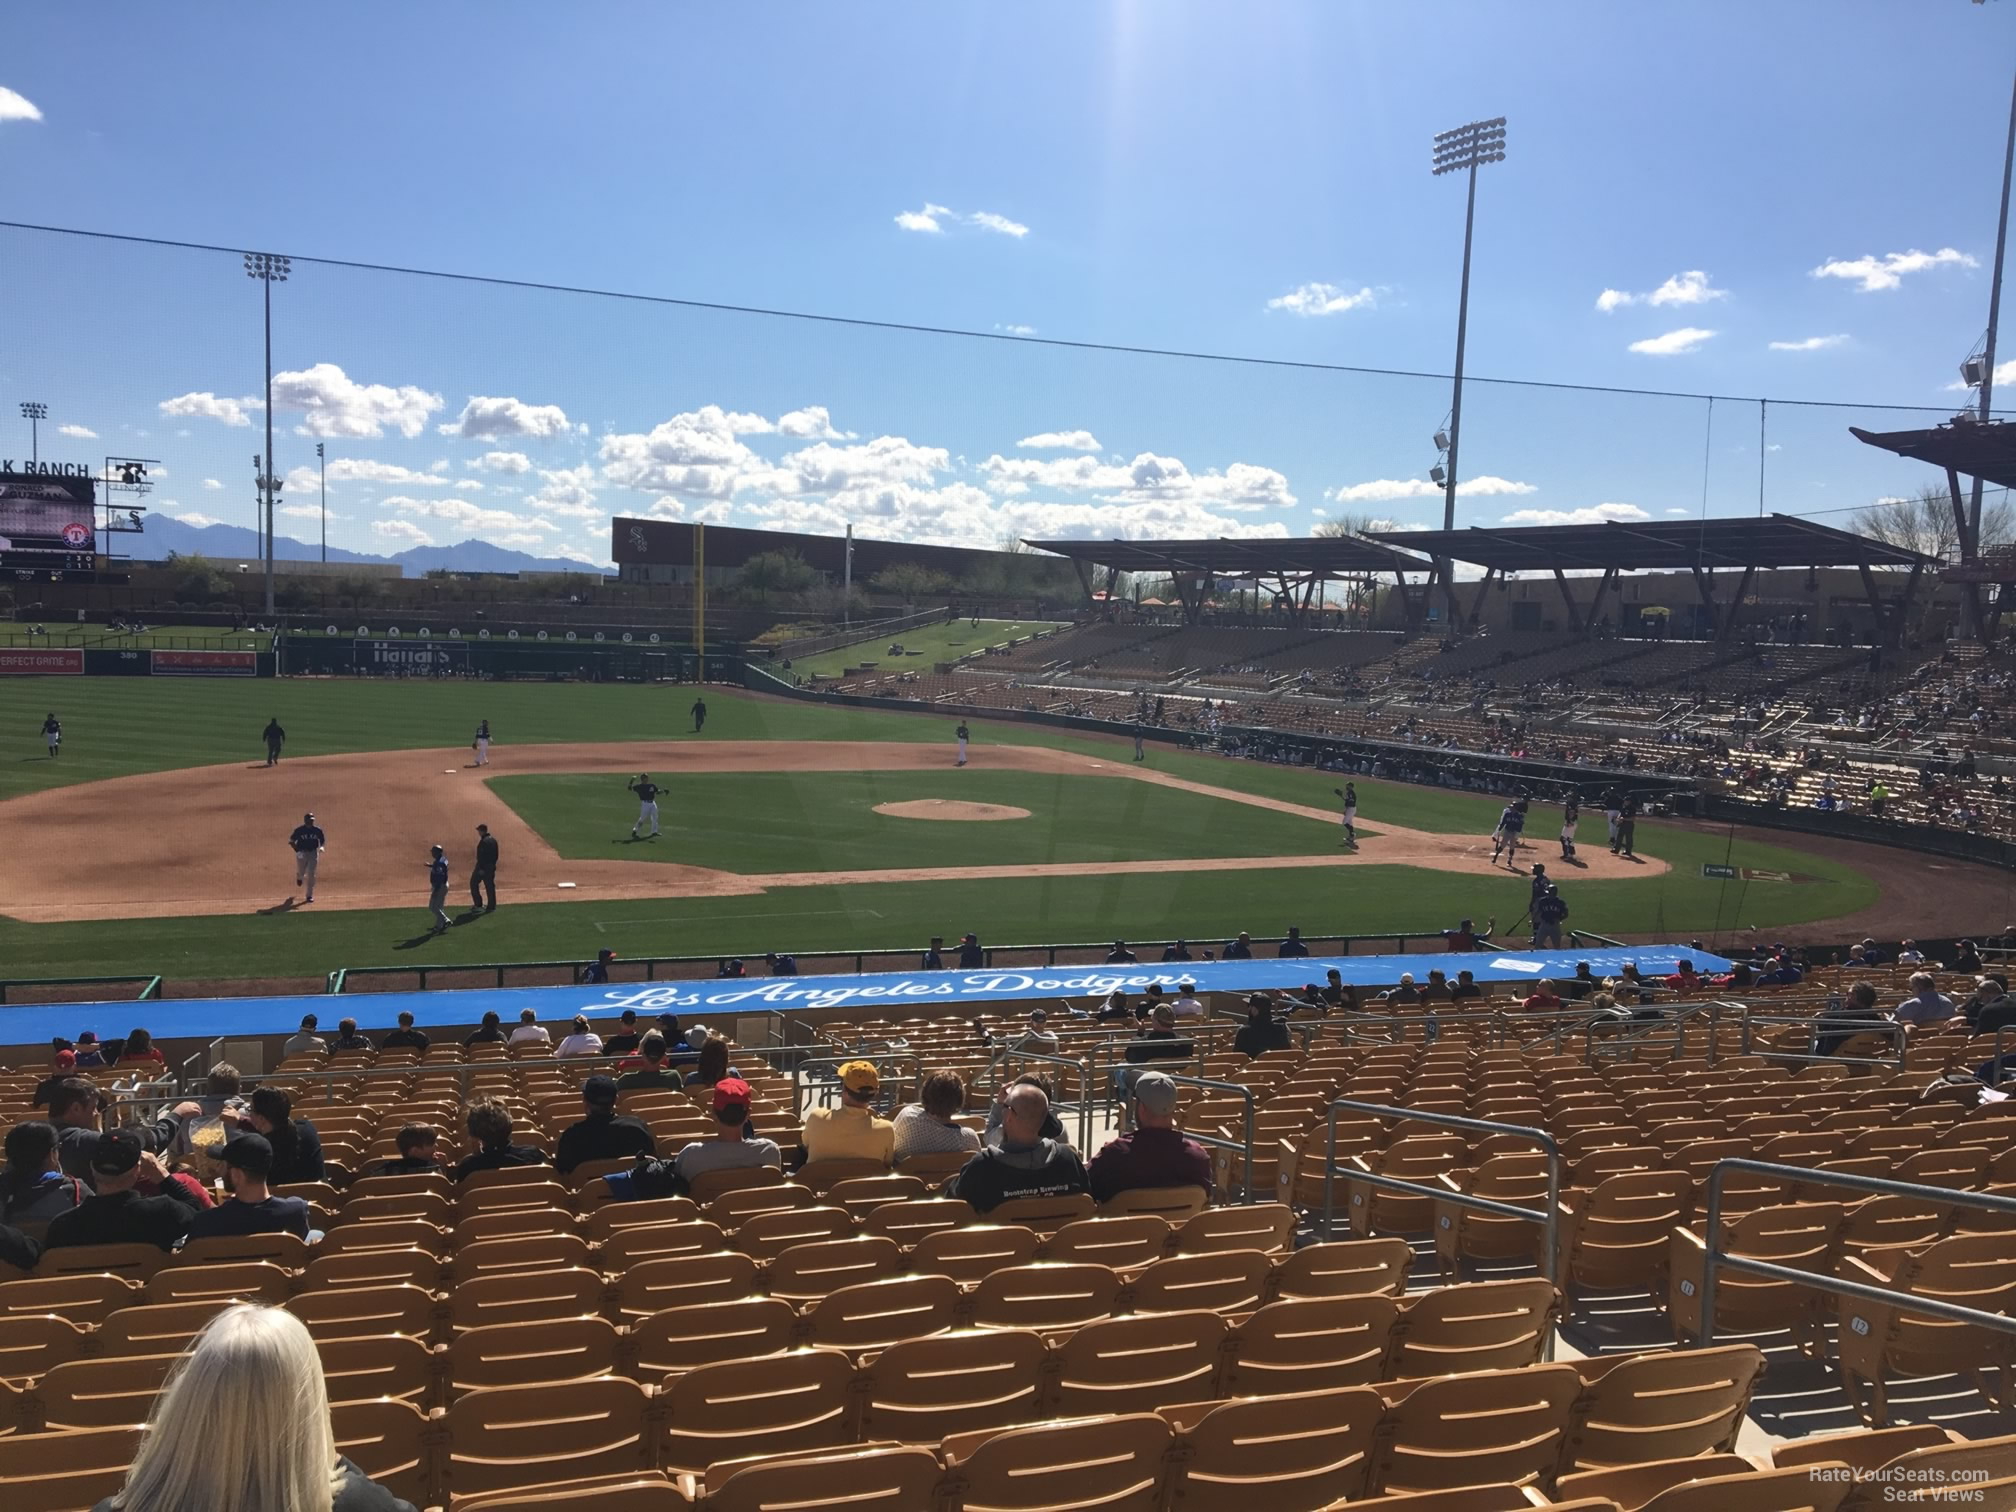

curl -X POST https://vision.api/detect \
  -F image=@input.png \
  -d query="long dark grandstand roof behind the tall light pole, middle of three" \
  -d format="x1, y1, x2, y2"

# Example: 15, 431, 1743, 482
1369, 514, 1935, 573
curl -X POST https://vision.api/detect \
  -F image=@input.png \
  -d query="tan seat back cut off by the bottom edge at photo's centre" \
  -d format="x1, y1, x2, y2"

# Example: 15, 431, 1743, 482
943, 1413, 1173, 1512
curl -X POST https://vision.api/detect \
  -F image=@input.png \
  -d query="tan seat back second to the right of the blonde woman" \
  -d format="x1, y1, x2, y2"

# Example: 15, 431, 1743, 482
442, 1375, 655, 1498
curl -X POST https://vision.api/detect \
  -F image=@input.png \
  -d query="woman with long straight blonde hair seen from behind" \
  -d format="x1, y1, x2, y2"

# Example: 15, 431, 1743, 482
93, 1304, 413, 1512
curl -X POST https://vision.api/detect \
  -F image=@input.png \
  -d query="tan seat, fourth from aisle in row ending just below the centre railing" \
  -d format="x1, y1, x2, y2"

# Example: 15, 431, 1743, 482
857, 1329, 1048, 1443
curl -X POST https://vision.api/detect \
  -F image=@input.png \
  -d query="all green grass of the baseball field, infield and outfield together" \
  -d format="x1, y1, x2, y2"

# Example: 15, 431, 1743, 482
0, 677, 1877, 978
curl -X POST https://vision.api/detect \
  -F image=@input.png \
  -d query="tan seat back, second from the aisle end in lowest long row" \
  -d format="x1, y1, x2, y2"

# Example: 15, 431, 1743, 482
1373, 1365, 1583, 1494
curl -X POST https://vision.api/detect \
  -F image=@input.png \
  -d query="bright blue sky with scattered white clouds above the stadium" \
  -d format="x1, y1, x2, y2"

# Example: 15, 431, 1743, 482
0, 0, 2016, 560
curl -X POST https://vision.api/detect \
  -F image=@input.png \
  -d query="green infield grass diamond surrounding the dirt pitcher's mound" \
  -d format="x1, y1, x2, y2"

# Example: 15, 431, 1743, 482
490, 768, 1369, 873
